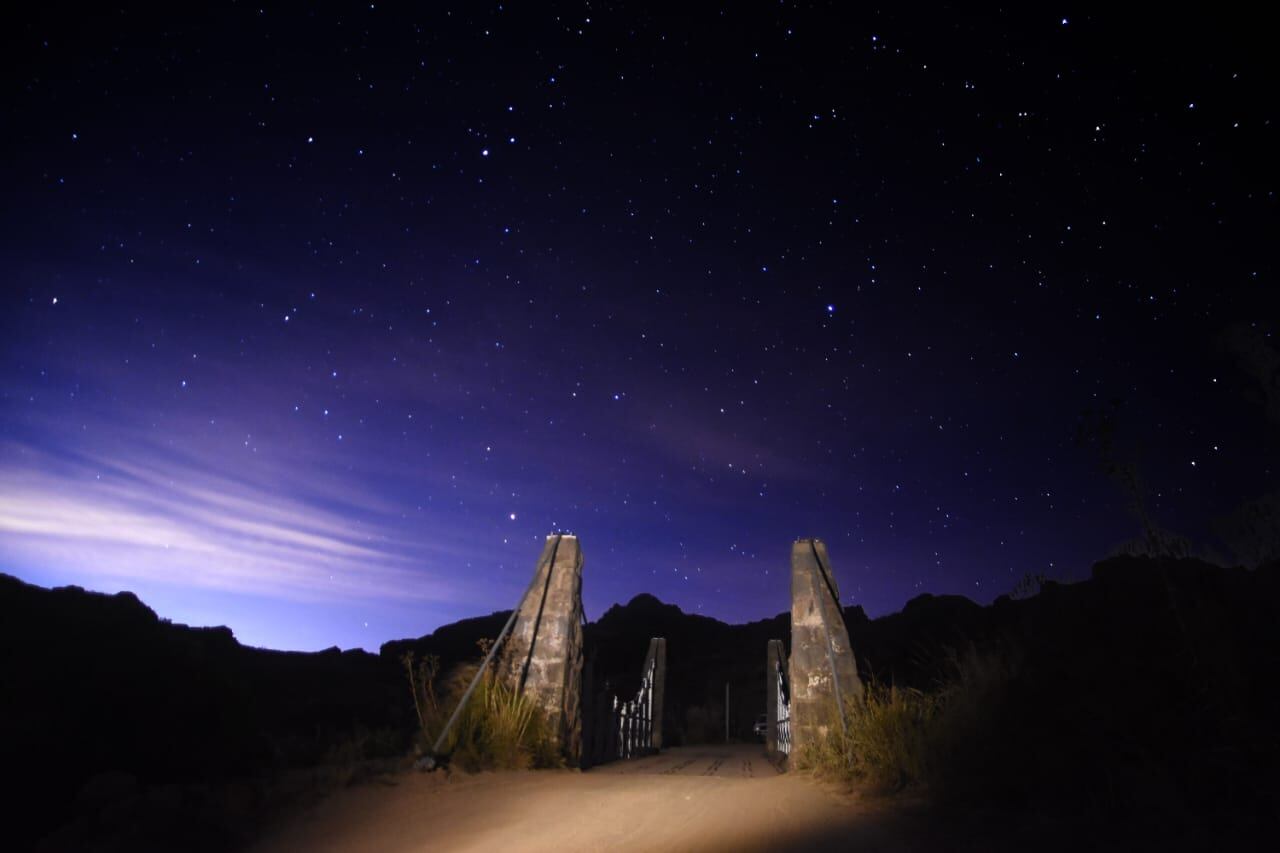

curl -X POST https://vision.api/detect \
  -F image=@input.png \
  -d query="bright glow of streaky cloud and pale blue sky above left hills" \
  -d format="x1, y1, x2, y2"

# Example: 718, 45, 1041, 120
0, 442, 506, 648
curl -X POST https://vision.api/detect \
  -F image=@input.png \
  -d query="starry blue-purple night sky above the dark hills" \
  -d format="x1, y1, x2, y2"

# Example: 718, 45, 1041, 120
0, 3, 1280, 649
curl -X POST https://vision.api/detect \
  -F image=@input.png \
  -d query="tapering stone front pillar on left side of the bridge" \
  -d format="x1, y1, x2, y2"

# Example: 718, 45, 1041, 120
498, 534, 582, 762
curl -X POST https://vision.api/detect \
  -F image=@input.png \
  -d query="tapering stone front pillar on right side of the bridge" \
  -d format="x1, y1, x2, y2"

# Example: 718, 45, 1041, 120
790, 539, 863, 749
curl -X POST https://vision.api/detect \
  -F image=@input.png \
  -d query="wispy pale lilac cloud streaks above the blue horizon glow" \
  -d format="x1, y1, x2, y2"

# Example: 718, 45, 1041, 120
0, 443, 461, 601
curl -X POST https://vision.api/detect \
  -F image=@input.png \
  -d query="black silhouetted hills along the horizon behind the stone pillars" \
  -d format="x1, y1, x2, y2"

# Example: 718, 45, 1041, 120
0, 557, 1280, 849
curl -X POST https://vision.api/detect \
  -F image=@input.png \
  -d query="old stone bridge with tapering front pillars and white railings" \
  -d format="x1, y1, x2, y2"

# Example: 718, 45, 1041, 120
429, 533, 863, 776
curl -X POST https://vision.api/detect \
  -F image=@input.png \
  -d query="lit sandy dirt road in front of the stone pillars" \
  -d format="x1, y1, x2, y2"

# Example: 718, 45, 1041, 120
252, 745, 918, 853
